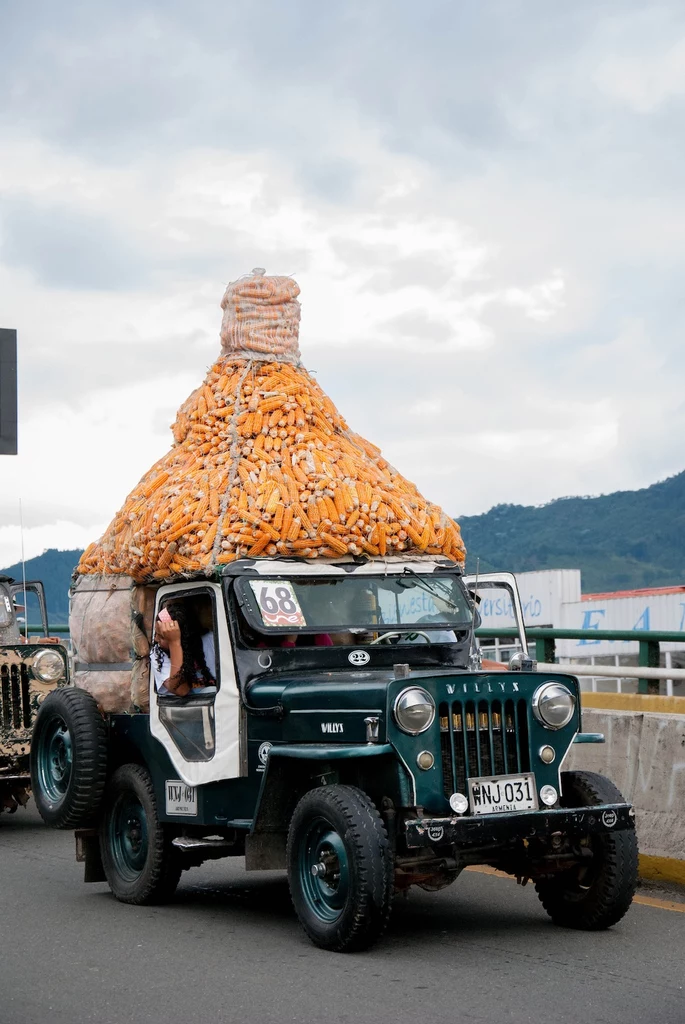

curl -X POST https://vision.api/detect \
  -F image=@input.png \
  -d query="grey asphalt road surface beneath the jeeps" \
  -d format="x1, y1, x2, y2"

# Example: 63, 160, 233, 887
0, 808, 685, 1024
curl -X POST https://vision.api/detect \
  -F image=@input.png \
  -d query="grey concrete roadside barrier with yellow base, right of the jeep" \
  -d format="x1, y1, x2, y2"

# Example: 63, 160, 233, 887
564, 707, 685, 884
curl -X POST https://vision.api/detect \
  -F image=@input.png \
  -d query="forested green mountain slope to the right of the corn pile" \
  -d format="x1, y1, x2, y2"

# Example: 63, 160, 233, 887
458, 472, 685, 594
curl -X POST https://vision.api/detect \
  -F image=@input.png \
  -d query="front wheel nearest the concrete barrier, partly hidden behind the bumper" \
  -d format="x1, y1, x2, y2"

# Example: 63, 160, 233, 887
536, 771, 638, 932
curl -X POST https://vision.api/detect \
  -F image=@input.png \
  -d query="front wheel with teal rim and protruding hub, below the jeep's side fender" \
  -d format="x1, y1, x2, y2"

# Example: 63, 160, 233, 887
287, 785, 394, 952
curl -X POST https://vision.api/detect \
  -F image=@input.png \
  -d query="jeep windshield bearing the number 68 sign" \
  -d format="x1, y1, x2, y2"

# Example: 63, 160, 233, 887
232, 570, 472, 644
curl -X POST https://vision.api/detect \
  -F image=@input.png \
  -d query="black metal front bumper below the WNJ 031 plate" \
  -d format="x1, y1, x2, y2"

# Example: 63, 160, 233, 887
404, 804, 635, 848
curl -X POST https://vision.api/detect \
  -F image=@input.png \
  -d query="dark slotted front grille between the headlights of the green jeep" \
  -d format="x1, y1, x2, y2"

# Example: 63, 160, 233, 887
439, 700, 530, 797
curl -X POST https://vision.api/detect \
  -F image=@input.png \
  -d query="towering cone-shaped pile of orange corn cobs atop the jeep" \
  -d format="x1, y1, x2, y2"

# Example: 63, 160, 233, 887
77, 270, 464, 583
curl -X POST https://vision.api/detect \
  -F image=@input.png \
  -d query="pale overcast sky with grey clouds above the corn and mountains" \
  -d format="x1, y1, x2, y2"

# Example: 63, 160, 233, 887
0, 0, 685, 566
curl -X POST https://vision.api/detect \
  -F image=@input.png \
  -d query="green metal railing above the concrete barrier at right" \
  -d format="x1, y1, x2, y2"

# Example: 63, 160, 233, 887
476, 626, 685, 693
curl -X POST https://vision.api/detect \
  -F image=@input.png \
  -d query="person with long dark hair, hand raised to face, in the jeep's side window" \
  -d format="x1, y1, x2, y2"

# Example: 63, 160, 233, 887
151, 597, 217, 697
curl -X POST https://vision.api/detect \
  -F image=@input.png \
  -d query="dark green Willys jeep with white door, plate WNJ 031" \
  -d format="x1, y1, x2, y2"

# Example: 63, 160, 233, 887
26, 558, 638, 951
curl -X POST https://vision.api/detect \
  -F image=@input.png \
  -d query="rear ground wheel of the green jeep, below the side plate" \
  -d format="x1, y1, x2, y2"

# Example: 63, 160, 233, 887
99, 765, 182, 905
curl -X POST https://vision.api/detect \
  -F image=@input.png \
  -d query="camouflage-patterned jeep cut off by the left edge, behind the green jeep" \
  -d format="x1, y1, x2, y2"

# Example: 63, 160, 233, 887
0, 575, 69, 814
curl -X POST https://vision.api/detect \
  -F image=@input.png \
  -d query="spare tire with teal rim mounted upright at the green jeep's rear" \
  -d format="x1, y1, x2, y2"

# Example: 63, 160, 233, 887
30, 686, 108, 828
